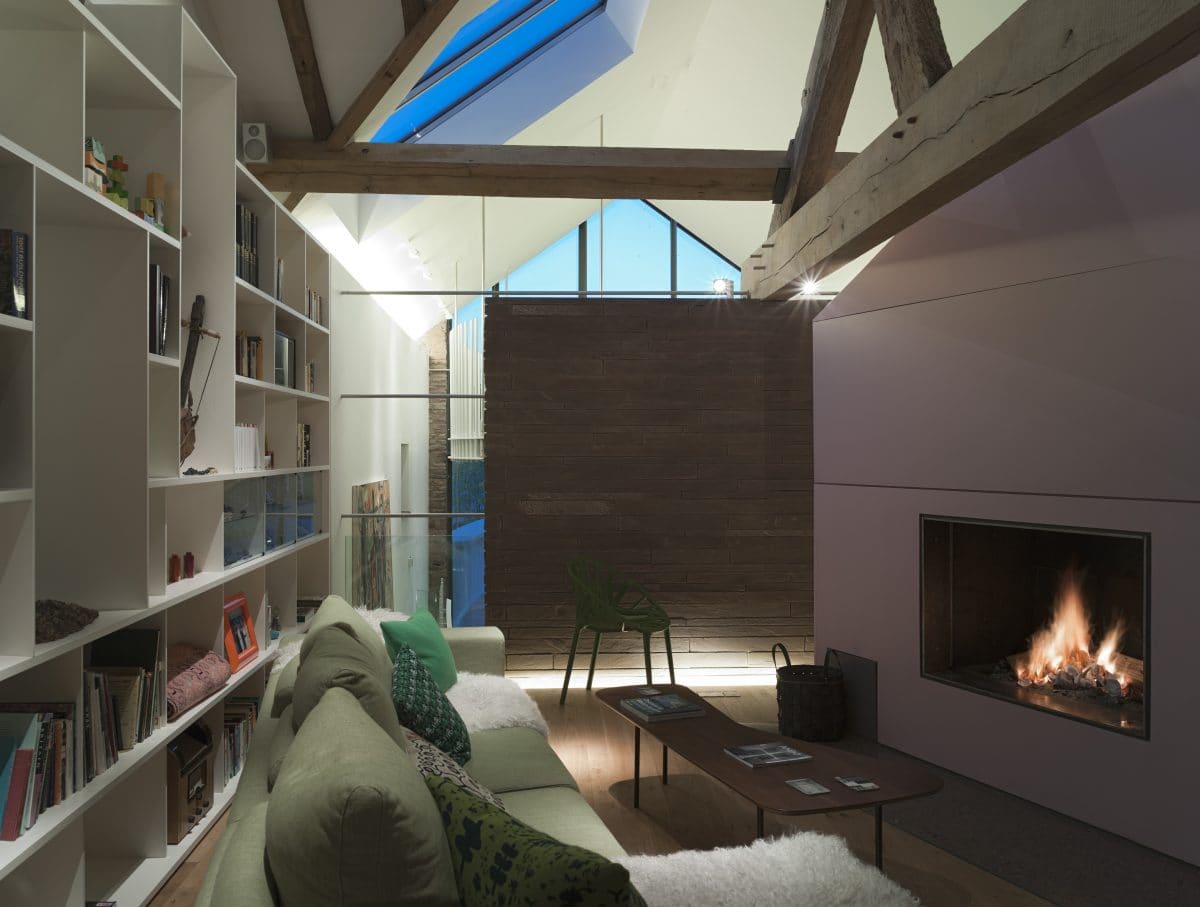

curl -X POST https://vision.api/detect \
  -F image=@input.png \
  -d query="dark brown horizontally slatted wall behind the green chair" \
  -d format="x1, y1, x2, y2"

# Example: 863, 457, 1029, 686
485, 299, 818, 669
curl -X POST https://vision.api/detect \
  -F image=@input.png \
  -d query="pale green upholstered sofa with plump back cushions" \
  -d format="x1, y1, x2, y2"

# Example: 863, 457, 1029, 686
196, 596, 624, 907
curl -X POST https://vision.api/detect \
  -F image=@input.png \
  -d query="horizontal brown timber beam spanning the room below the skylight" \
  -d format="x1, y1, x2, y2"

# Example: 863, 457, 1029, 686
252, 143, 792, 200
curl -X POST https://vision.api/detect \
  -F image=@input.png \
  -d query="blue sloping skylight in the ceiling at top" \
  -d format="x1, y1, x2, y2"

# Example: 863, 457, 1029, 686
374, 0, 606, 142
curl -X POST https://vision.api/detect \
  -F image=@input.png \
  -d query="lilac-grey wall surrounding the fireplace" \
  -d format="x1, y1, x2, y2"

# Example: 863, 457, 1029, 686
814, 58, 1200, 865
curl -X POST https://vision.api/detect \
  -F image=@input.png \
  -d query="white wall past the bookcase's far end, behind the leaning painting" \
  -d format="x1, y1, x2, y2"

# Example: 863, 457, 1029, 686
330, 259, 430, 611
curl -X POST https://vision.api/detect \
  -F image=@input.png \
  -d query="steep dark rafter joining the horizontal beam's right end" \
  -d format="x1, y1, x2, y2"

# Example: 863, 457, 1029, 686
770, 0, 875, 232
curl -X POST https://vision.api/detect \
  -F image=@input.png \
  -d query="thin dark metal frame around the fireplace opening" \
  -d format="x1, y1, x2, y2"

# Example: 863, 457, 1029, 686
917, 513, 1152, 743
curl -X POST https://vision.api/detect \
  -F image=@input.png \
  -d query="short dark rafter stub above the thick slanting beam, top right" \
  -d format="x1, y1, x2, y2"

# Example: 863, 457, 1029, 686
875, 0, 952, 113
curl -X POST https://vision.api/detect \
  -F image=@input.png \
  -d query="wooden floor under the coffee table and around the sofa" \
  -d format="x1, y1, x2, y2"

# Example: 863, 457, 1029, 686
151, 686, 1049, 907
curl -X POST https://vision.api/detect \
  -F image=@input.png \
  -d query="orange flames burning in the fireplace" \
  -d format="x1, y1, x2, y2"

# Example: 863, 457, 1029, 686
1016, 571, 1128, 690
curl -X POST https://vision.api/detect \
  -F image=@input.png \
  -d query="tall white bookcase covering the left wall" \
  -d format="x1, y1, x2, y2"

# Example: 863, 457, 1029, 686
0, 0, 331, 907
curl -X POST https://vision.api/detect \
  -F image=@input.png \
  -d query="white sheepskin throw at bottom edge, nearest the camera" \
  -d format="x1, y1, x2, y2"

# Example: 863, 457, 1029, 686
619, 831, 919, 907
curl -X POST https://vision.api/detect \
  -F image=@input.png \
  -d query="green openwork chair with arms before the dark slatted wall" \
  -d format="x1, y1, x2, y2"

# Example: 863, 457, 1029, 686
558, 557, 674, 705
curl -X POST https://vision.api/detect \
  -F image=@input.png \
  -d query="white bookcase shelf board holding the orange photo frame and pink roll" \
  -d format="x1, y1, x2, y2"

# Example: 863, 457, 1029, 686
0, 643, 278, 879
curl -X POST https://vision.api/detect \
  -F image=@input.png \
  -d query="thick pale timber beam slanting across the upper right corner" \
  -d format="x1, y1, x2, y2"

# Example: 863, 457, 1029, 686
743, 0, 1200, 299
